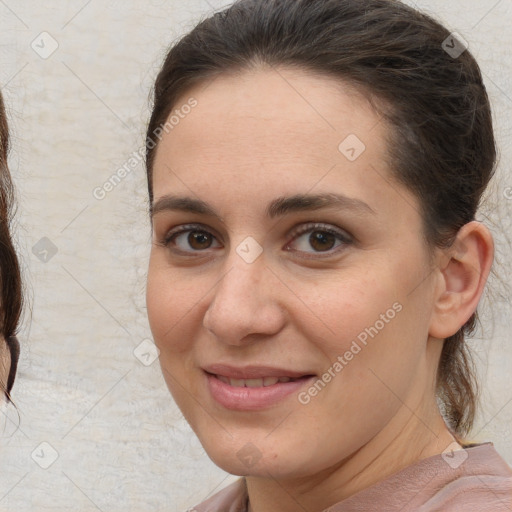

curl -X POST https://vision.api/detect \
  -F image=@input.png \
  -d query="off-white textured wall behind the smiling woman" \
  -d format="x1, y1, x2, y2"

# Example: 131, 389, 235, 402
0, 0, 512, 512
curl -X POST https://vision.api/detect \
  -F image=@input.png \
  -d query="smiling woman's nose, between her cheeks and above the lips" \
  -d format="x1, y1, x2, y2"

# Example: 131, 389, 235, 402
203, 254, 286, 346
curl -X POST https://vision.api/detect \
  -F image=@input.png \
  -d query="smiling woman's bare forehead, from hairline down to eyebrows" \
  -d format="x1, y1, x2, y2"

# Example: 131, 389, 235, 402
149, 68, 416, 222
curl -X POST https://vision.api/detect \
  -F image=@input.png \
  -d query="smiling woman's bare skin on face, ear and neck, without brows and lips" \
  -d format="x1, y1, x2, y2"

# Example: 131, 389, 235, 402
147, 67, 493, 512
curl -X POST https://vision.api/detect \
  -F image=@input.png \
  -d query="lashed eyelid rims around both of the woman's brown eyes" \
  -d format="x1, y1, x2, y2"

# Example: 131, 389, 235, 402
160, 222, 353, 258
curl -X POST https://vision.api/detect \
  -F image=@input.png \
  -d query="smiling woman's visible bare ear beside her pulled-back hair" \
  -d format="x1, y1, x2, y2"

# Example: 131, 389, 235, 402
429, 221, 494, 339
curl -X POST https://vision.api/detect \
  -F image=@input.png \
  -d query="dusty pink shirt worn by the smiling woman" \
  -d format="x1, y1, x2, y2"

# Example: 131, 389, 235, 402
191, 443, 512, 512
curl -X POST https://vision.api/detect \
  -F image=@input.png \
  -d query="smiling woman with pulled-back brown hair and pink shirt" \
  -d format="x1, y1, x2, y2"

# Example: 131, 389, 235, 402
143, 0, 512, 512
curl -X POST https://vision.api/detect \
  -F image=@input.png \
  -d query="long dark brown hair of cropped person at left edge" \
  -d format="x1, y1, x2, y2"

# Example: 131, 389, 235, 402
0, 94, 22, 400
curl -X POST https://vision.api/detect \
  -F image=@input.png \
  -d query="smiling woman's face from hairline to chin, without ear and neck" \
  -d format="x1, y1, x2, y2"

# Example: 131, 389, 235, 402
147, 68, 440, 477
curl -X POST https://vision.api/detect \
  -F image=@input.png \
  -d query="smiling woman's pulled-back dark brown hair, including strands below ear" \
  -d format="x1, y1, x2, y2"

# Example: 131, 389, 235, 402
146, 0, 496, 436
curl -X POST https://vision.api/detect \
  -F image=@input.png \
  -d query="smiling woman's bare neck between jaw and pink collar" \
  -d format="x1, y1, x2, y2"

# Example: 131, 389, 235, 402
246, 402, 456, 512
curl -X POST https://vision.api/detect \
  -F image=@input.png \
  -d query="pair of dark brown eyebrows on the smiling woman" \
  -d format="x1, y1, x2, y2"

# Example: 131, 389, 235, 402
150, 193, 376, 218
